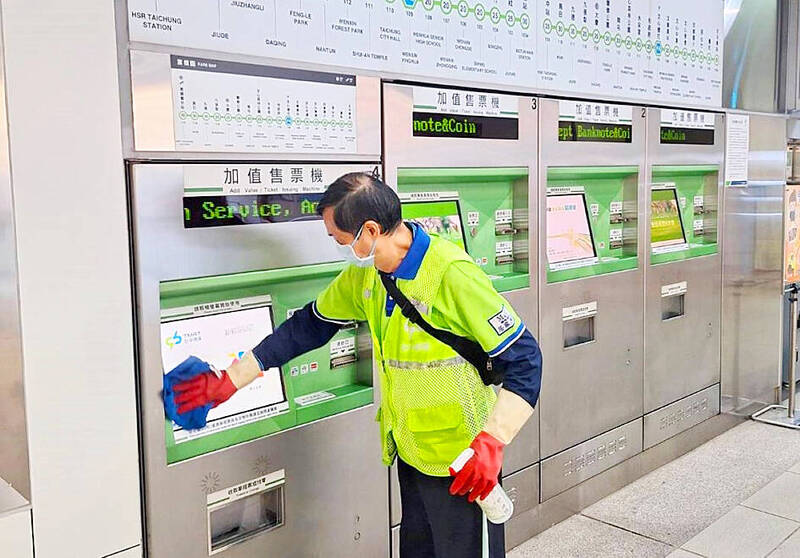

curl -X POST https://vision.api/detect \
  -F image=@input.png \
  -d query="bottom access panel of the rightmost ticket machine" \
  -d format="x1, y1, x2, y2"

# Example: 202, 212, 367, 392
644, 384, 719, 449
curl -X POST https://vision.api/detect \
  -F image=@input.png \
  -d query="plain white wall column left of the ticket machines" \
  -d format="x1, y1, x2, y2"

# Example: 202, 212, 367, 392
0, 0, 141, 558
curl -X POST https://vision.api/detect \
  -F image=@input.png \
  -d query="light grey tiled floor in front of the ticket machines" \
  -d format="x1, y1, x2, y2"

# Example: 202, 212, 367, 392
508, 422, 800, 558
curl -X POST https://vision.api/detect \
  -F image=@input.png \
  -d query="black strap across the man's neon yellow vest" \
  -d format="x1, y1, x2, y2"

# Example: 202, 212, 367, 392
380, 272, 503, 386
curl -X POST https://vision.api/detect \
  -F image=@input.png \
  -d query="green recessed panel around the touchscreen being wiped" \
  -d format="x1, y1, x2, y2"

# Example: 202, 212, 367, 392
160, 263, 373, 464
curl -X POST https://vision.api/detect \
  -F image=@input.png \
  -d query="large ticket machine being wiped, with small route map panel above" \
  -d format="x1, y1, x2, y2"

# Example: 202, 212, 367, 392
129, 52, 389, 558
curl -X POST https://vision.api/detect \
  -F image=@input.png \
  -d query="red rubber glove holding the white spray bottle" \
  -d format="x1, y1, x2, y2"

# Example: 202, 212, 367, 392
450, 432, 505, 502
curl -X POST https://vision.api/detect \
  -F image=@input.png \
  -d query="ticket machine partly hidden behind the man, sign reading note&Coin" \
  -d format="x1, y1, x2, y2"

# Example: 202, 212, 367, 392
383, 84, 539, 548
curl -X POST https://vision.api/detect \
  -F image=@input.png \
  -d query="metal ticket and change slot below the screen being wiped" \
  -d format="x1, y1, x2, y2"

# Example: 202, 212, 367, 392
208, 484, 284, 554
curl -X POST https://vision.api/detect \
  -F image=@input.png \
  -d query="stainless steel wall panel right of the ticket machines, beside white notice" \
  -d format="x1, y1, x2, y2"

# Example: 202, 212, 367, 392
721, 114, 786, 413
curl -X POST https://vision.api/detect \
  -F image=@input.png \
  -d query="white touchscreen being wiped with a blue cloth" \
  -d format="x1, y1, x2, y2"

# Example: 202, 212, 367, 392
161, 302, 289, 444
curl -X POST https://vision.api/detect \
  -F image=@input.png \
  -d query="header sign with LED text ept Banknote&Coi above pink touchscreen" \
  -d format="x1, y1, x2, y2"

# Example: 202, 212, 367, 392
558, 101, 633, 143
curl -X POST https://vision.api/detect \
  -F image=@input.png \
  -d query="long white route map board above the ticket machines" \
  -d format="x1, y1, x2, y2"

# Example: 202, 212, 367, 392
128, 0, 723, 107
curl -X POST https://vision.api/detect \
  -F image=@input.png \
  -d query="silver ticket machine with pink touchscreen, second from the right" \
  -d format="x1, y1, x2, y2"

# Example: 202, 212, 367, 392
539, 100, 646, 501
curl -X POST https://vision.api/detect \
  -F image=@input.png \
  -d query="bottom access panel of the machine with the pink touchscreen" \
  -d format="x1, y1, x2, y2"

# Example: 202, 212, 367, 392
541, 418, 642, 502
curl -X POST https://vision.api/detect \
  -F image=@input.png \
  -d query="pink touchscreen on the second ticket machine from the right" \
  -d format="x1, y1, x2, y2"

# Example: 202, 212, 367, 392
547, 193, 597, 269
